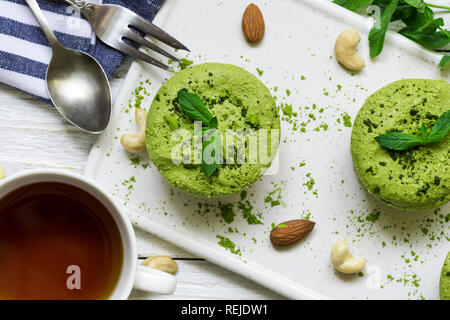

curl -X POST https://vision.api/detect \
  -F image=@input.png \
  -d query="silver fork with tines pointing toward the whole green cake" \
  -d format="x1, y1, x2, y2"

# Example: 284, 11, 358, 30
65, 0, 189, 70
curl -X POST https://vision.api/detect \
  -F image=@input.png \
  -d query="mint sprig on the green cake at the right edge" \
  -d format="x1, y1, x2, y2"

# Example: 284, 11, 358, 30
375, 110, 450, 151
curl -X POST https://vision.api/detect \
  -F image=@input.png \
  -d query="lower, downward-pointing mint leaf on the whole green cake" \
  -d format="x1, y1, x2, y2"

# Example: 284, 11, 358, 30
202, 129, 222, 179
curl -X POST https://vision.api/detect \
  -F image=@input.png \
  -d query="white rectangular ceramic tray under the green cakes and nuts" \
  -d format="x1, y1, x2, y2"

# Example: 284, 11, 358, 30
85, 0, 450, 299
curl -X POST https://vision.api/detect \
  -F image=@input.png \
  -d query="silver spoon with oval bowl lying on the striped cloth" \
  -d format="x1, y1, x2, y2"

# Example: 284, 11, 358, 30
25, 0, 112, 133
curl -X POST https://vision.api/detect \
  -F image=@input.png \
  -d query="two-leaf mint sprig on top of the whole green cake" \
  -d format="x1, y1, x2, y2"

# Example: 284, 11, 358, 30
178, 90, 222, 179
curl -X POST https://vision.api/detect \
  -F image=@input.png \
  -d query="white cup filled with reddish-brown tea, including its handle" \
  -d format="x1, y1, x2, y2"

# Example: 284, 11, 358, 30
0, 170, 176, 300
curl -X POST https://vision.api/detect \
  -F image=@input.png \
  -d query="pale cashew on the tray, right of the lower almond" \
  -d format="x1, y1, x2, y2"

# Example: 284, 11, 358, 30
331, 238, 366, 273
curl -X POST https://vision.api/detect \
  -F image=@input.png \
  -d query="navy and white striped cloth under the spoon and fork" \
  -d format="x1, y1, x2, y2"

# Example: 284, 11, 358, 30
0, 0, 164, 101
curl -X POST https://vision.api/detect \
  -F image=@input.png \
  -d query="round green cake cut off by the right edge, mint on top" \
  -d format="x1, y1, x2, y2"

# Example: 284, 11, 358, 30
351, 79, 450, 210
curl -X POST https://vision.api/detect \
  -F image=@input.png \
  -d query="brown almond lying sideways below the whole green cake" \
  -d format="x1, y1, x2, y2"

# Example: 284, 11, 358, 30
270, 220, 316, 247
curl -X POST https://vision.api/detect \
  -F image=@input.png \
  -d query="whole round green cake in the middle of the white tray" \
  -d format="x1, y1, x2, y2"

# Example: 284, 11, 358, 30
146, 63, 280, 197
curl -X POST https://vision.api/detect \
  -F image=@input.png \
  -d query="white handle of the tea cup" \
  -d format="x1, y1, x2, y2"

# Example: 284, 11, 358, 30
134, 265, 177, 294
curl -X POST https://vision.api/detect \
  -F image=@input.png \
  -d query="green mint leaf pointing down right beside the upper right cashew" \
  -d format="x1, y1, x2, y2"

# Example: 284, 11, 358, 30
369, 0, 398, 59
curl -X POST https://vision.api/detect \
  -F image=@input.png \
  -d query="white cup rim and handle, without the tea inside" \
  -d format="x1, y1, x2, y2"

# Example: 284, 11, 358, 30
0, 169, 177, 300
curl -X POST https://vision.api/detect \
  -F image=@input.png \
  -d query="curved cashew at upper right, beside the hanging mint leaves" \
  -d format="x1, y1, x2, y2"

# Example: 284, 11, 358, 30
334, 29, 365, 71
